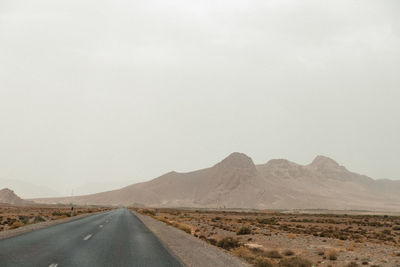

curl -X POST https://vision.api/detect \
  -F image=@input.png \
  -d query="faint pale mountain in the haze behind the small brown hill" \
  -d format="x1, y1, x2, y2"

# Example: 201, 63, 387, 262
0, 178, 62, 198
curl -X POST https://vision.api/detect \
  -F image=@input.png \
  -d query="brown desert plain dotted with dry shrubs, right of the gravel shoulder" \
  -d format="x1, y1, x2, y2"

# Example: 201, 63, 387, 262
134, 209, 400, 267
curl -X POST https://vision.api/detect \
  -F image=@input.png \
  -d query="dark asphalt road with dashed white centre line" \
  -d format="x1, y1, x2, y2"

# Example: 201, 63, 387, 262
0, 209, 182, 267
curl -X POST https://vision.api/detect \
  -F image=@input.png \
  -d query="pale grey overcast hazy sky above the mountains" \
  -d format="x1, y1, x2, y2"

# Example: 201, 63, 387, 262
0, 0, 400, 197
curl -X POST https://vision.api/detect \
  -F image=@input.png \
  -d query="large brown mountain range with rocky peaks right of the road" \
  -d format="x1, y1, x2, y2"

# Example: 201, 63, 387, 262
35, 153, 400, 213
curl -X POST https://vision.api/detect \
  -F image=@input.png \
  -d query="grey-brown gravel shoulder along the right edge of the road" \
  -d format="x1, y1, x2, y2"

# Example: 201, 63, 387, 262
134, 212, 250, 267
